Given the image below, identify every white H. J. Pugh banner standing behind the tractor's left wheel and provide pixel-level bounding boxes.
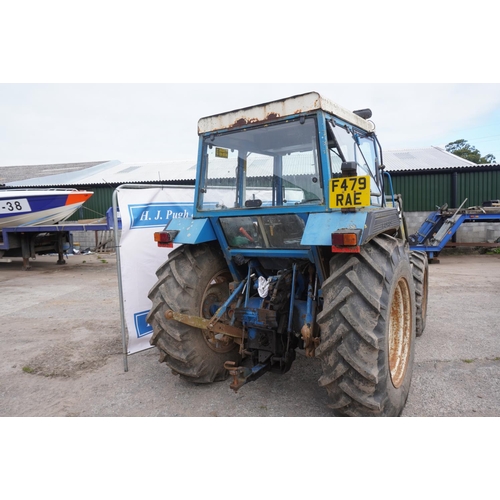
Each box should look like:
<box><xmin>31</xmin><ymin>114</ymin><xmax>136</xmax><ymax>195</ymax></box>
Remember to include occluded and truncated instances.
<box><xmin>118</xmin><ymin>186</ymin><xmax>194</xmax><ymax>354</ymax></box>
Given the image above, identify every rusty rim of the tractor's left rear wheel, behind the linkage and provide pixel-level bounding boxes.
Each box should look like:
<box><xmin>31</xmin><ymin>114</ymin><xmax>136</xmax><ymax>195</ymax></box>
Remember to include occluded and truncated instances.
<box><xmin>200</xmin><ymin>271</ymin><xmax>234</xmax><ymax>353</ymax></box>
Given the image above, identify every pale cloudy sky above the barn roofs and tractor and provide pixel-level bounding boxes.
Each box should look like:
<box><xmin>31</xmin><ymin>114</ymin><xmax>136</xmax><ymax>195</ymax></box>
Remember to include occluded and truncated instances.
<box><xmin>0</xmin><ymin>83</ymin><xmax>500</xmax><ymax>166</ymax></box>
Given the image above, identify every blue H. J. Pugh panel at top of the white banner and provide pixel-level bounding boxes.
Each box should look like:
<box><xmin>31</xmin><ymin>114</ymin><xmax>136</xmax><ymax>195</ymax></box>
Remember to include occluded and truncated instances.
<box><xmin>128</xmin><ymin>202</ymin><xmax>193</xmax><ymax>229</ymax></box>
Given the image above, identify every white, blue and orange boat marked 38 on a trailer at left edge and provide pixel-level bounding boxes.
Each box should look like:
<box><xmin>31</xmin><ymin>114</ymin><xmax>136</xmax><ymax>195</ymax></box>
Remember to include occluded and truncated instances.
<box><xmin>0</xmin><ymin>188</ymin><xmax>94</xmax><ymax>228</ymax></box>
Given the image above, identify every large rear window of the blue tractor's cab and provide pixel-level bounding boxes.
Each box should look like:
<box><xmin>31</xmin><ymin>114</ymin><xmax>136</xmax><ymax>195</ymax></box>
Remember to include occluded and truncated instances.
<box><xmin>198</xmin><ymin>117</ymin><xmax>323</xmax><ymax>210</ymax></box>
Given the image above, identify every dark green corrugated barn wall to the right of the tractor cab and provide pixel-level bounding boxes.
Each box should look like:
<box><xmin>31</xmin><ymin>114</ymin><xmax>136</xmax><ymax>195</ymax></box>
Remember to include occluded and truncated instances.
<box><xmin>392</xmin><ymin>170</ymin><xmax>500</xmax><ymax>212</ymax></box>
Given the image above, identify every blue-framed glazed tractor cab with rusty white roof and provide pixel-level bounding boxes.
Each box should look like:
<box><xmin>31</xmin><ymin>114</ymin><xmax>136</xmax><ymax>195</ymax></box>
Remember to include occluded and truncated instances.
<box><xmin>194</xmin><ymin>93</ymin><xmax>383</xmax><ymax>218</ymax></box>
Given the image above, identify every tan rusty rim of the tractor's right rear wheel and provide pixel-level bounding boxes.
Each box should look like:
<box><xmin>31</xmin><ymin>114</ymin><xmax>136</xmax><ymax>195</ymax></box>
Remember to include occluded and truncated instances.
<box><xmin>389</xmin><ymin>278</ymin><xmax>412</xmax><ymax>388</ymax></box>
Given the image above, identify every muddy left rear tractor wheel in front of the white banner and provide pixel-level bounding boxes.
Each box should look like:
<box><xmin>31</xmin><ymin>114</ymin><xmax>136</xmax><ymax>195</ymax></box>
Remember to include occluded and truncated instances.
<box><xmin>147</xmin><ymin>244</ymin><xmax>240</xmax><ymax>384</ymax></box>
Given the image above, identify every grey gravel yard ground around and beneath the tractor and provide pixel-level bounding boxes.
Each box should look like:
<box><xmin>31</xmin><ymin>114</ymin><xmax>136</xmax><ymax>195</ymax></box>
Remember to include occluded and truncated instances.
<box><xmin>0</xmin><ymin>250</ymin><xmax>500</xmax><ymax>417</ymax></box>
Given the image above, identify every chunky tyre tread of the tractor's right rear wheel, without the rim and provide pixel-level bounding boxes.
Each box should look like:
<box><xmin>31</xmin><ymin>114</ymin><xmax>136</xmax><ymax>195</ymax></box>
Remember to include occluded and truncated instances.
<box><xmin>316</xmin><ymin>235</ymin><xmax>413</xmax><ymax>416</ymax></box>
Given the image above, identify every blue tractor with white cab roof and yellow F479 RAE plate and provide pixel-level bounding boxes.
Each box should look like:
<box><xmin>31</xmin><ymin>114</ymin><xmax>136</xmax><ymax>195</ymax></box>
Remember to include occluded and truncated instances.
<box><xmin>147</xmin><ymin>92</ymin><xmax>428</xmax><ymax>416</ymax></box>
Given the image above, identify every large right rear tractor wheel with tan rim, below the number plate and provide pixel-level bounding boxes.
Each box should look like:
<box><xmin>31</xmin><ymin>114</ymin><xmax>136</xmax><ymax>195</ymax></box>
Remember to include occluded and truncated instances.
<box><xmin>316</xmin><ymin>235</ymin><xmax>415</xmax><ymax>416</ymax></box>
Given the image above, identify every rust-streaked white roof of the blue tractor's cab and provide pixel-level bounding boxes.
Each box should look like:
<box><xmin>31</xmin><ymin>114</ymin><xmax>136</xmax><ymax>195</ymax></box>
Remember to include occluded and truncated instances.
<box><xmin>198</xmin><ymin>92</ymin><xmax>375</xmax><ymax>135</ymax></box>
